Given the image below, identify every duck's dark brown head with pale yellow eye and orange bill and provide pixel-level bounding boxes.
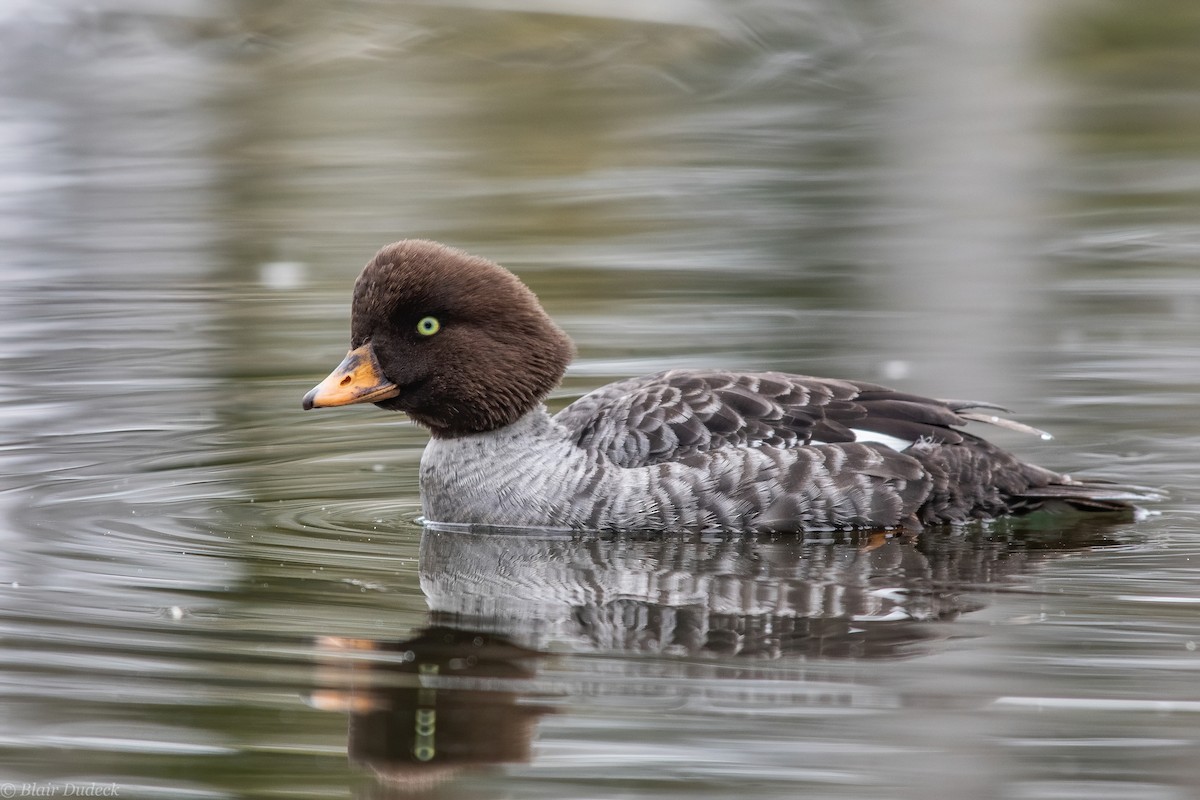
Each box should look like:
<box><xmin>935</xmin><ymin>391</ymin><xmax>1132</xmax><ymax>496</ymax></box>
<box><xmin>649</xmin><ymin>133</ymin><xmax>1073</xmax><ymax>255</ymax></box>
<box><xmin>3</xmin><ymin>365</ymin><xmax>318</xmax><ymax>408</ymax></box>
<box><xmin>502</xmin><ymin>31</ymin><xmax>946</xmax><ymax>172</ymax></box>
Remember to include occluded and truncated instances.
<box><xmin>304</xmin><ymin>240</ymin><xmax>574</xmax><ymax>437</ymax></box>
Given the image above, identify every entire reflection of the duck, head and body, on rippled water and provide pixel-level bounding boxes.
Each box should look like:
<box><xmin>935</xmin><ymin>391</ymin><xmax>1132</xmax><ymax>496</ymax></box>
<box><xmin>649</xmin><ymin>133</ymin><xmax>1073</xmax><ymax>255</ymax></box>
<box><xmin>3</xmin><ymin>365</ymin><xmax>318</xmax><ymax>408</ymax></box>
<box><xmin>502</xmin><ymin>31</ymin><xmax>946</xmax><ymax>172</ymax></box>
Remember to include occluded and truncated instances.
<box><xmin>313</xmin><ymin>521</ymin><xmax>1114</xmax><ymax>795</ymax></box>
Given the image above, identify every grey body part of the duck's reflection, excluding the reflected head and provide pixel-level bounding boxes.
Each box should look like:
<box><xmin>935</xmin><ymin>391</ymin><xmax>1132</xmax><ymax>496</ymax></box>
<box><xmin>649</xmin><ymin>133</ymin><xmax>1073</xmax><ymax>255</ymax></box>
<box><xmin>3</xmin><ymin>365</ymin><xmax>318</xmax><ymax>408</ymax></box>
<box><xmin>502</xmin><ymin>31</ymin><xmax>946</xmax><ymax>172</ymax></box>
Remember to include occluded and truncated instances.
<box><xmin>420</xmin><ymin>521</ymin><xmax>1112</xmax><ymax>658</ymax></box>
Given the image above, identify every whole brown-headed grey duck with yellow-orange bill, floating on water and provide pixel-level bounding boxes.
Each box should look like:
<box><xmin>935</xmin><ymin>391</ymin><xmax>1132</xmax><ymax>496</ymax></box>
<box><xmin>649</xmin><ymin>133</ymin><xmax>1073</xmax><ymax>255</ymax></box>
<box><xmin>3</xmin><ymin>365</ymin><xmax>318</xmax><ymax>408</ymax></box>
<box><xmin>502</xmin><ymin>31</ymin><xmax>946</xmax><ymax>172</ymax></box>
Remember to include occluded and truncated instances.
<box><xmin>302</xmin><ymin>239</ymin><xmax>1150</xmax><ymax>533</ymax></box>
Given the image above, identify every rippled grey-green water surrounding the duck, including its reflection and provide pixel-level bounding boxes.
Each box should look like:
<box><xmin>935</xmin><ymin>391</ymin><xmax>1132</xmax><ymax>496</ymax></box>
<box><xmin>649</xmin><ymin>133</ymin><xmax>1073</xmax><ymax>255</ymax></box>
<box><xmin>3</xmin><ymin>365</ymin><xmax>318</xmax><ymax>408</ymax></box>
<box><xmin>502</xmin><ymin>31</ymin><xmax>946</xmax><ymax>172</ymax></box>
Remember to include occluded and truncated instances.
<box><xmin>0</xmin><ymin>0</ymin><xmax>1200</xmax><ymax>800</ymax></box>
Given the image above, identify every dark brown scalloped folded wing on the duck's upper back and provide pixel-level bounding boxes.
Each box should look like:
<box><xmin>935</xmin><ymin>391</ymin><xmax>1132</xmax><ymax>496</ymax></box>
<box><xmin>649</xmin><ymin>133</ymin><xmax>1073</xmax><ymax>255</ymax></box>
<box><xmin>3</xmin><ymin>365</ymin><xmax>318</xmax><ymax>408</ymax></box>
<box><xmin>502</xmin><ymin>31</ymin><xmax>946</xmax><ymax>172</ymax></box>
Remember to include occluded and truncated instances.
<box><xmin>556</xmin><ymin>369</ymin><xmax>978</xmax><ymax>467</ymax></box>
